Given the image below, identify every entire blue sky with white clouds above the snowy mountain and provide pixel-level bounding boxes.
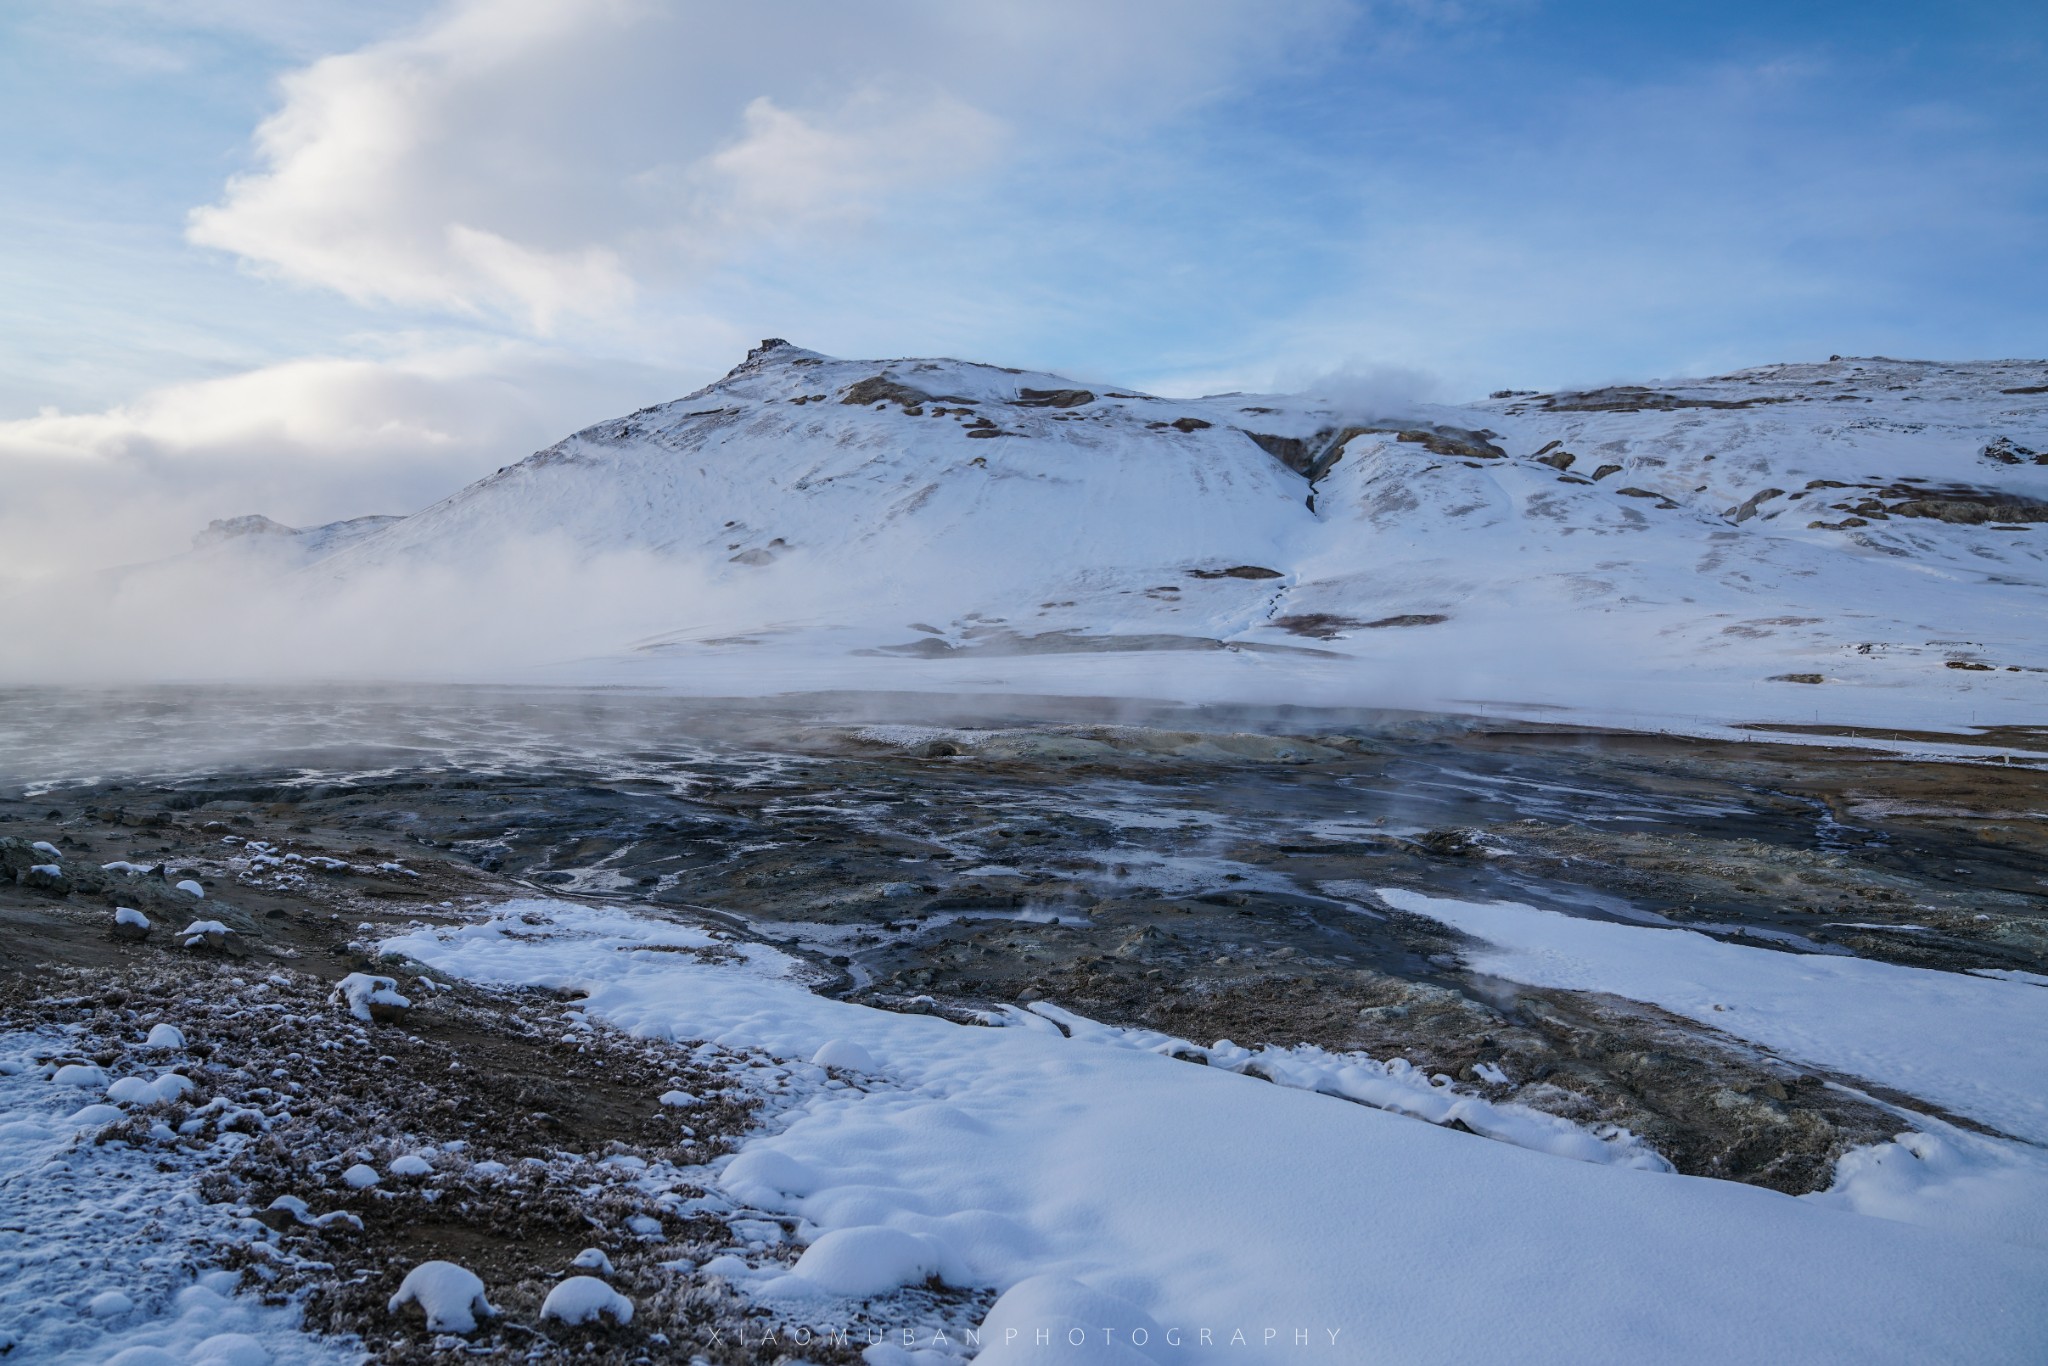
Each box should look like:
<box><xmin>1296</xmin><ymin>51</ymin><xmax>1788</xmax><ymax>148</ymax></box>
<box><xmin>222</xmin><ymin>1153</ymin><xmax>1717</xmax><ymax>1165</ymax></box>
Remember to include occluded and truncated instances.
<box><xmin>0</xmin><ymin>0</ymin><xmax>2048</xmax><ymax>571</ymax></box>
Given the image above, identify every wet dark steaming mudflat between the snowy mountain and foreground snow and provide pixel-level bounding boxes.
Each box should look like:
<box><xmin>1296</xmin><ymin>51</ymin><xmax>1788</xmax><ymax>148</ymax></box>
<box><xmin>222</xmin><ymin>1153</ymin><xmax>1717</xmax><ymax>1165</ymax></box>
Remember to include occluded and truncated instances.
<box><xmin>0</xmin><ymin>690</ymin><xmax>2048</xmax><ymax>1220</ymax></box>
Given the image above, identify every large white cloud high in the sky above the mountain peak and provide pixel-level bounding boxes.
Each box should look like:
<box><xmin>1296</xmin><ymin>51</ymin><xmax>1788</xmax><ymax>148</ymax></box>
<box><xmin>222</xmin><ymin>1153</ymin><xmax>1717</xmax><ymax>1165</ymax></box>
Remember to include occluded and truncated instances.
<box><xmin>188</xmin><ymin>0</ymin><xmax>1343</xmax><ymax>332</ymax></box>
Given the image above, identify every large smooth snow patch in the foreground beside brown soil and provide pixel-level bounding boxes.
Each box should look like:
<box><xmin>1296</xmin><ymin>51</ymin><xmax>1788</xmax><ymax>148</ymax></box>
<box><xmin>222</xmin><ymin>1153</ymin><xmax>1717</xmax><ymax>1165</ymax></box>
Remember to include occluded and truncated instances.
<box><xmin>385</xmin><ymin>901</ymin><xmax>2048</xmax><ymax>1362</ymax></box>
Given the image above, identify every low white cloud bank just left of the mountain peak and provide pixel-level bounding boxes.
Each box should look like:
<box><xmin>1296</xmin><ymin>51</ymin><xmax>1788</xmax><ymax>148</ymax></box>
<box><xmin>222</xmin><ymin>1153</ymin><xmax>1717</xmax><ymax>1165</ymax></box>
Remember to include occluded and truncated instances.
<box><xmin>0</xmin><ymin>346</ymin><xmax>692</xmax><ymax>586</ymax></box>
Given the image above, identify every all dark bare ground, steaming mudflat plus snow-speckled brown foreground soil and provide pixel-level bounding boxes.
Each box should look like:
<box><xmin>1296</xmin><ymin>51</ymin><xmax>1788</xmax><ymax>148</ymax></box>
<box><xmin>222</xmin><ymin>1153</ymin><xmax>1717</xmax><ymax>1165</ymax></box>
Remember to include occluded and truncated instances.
<box><xmin>0</xmin><ymin>692</ymin><xmax>2048</xmax><ymax>1364</ymax></box>
